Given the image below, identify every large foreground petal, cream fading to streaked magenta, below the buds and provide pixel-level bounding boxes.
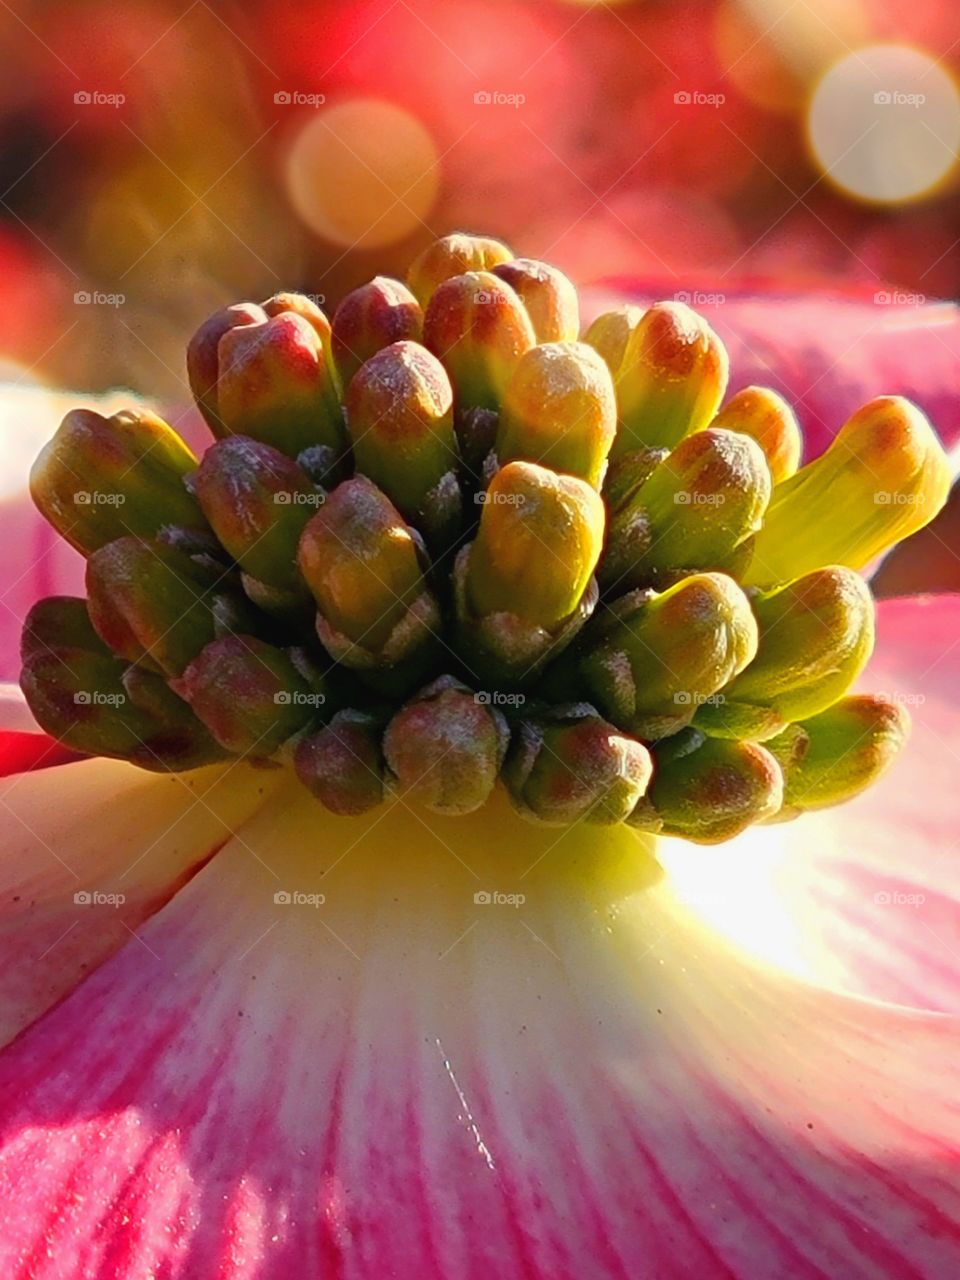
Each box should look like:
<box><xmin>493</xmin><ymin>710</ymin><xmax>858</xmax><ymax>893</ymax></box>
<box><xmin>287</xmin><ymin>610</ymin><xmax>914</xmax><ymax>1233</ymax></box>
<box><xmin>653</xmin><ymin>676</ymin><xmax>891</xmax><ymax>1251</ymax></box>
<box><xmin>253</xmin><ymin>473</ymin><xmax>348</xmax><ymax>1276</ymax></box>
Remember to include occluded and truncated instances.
<box><xmin>0</xmin><ymin>773</ymin><xmax>960</xmax><ymax>1280</ymax></box>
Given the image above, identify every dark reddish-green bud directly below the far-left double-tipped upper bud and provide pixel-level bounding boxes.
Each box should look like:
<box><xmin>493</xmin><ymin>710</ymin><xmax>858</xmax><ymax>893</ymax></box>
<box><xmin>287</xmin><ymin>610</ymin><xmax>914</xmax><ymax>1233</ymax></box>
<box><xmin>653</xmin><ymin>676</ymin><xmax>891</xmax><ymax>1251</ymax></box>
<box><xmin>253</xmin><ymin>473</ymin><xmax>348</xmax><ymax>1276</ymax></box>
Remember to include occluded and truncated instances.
<box><xmin>87</xmin><ymin>538</ymin><xmax>224</xmax><ymax>676</ymax></box>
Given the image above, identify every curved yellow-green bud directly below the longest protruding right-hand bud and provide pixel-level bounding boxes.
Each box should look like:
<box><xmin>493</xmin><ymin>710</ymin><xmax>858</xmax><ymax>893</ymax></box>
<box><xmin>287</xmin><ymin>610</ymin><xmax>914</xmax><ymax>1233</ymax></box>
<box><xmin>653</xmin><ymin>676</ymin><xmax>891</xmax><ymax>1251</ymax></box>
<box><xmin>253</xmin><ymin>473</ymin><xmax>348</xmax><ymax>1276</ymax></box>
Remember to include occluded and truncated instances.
<box><xmin>696</xmin><ymin>564</ymin><xmax>874</xmax><ymax>739</ymax></box>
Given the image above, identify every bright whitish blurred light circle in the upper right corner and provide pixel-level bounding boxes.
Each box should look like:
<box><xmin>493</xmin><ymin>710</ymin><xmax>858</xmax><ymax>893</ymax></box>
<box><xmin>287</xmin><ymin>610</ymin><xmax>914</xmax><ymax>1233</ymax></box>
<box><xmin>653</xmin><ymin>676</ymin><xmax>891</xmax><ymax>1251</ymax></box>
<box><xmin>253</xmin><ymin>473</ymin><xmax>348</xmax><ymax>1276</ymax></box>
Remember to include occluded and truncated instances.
<box><xmin>808</xmin><ymin>45</ymin><xmax>960</xmax><ymax>204</ymax></box>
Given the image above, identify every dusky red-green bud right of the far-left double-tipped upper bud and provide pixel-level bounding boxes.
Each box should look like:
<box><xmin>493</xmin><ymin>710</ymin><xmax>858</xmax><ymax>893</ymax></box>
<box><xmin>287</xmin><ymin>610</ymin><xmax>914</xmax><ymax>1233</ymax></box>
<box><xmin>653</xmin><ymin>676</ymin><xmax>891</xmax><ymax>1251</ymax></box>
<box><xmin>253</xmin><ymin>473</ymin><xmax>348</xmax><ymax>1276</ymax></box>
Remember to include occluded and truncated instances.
<box><xmin>195</xmin><ymin>435</ymin><xmax>324</xmax><ymax>588</ymax></box>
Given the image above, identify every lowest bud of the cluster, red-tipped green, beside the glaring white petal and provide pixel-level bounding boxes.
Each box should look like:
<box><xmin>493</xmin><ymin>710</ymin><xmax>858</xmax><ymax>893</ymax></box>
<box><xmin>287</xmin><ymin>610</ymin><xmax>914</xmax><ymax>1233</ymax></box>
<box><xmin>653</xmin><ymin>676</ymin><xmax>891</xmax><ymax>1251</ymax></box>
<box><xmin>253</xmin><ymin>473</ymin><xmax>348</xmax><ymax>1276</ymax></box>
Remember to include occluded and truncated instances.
<box><xmin>628</xmin><ymin>733</ymin><xmax>783</xmax><ymax>845</ymax></box>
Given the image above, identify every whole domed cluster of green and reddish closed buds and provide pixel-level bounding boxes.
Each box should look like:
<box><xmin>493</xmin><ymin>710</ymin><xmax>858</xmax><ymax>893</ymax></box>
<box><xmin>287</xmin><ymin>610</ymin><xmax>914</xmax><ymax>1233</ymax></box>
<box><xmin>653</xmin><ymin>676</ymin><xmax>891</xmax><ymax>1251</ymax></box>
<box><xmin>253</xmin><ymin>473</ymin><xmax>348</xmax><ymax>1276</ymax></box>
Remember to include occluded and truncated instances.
<box><xmin>22</xmin><ymin>236</ymin><xmax>948</xmax><ymax>842</ymax></box>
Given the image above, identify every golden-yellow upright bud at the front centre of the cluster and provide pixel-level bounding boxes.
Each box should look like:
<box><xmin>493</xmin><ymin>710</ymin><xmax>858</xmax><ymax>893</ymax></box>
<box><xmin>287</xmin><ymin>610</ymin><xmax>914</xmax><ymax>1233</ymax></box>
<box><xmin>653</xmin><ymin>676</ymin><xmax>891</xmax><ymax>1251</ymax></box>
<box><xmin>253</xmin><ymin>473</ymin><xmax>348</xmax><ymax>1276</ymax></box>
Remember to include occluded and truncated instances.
<box><xmin>466</xmin><ymin>462</ymin><xmax>604</xmax><ymax>630</ymax></box>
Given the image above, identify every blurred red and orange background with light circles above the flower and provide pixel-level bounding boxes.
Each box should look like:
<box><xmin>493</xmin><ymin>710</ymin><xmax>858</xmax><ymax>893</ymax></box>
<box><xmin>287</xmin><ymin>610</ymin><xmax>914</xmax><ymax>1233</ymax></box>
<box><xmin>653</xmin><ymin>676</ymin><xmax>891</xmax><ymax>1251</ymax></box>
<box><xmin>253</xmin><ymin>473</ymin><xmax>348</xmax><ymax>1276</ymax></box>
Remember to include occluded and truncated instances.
<box><xmin>0</xmin><ymin>0</ymin><xmax>960</xmax><ymax>399</ymax></box>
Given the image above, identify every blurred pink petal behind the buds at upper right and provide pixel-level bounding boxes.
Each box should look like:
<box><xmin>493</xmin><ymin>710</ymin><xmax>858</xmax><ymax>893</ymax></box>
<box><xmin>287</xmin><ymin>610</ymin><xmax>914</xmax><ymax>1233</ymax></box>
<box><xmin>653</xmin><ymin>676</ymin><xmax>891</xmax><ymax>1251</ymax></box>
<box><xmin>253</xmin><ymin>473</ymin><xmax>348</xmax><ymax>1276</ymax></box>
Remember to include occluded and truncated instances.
<box><xmin>584</xmin><ymin>280</ymin><xmax>960</xmax><ymax>461</ymax></box>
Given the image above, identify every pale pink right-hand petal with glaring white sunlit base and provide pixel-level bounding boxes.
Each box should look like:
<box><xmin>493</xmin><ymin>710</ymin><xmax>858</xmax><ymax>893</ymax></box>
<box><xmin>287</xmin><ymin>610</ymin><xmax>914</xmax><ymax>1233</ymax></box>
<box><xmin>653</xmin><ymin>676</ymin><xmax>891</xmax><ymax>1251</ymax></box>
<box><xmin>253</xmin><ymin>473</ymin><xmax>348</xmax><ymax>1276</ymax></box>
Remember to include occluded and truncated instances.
<box><xmin>662</xmin><ymin>595</ymin><xmax>960</xmax><ymax>1012</ymax></box>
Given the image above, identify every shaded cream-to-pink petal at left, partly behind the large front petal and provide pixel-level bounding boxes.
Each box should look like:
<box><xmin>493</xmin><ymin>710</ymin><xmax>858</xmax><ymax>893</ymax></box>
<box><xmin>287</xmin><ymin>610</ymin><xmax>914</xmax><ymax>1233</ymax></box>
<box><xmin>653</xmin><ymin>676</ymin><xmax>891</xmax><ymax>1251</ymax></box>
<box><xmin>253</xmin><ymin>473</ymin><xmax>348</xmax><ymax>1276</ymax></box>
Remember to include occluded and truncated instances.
<box><xmin>0</xmin><ymin>736</ymin><xmax>276</xmax><ymax>1043</ymax></box>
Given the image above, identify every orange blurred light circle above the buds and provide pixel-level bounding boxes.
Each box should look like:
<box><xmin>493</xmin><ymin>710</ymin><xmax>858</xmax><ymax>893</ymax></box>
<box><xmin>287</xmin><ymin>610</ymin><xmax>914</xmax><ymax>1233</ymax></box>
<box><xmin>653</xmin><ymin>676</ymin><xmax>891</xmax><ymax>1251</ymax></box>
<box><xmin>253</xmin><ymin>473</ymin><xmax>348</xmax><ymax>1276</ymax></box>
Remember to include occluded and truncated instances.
<box><xmin>287</xmin><ymin>99</ymin><xmax>440</xmax><ymax>250</ymax></box>
